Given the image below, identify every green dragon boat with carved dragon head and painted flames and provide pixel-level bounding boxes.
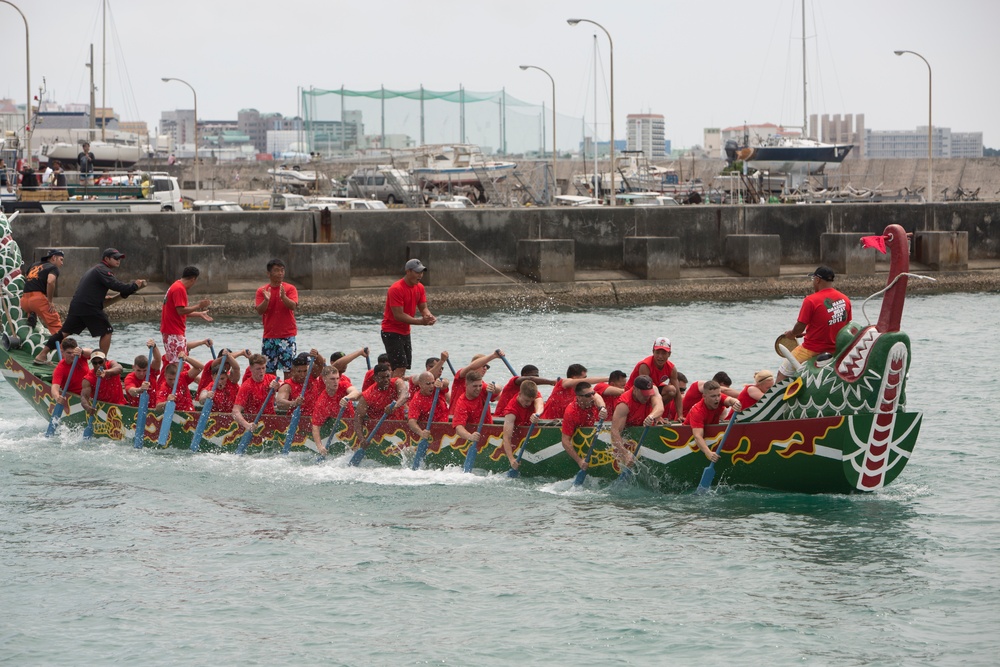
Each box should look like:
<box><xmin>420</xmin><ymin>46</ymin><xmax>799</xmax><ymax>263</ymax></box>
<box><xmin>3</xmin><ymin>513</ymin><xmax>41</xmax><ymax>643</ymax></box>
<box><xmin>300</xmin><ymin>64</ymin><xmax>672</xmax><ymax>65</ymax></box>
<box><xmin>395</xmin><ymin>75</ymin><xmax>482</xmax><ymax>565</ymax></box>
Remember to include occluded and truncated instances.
<box><xmin>0</xmin><ymin>214</ymin><xmax>921</xmax><ymax>493</ymax></box>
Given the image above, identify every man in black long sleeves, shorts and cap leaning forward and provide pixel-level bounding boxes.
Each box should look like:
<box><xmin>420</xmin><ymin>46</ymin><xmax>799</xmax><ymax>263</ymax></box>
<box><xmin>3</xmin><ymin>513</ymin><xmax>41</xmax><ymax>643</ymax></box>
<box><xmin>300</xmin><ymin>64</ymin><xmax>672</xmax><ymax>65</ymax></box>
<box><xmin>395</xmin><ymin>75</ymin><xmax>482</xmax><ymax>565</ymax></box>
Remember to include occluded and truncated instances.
<box><xmin>35</xmin><ymin>248</ymin><xmax>146</xmax><ymax>364</ymax></box>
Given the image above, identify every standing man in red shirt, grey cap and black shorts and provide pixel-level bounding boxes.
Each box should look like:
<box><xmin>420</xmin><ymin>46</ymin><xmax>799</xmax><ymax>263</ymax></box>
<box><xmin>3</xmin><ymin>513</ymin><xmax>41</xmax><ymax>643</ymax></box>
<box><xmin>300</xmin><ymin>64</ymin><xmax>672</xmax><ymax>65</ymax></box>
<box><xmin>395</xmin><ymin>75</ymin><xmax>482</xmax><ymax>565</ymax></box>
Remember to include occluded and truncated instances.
<box><xmin>382</xmin><ymin>259</ymin><xmax>437</xmax><ymax>378</ymax></box>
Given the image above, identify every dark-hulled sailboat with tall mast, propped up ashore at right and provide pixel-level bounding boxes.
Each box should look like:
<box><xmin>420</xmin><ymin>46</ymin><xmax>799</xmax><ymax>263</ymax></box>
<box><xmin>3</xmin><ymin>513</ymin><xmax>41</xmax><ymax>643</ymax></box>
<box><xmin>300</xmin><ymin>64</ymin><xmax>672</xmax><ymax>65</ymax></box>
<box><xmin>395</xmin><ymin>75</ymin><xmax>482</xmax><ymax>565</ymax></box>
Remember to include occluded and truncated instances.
<box><xmin>725</xmin><ymin>0</ymin><xmax>854</xmax><ymax>174</ymax></box>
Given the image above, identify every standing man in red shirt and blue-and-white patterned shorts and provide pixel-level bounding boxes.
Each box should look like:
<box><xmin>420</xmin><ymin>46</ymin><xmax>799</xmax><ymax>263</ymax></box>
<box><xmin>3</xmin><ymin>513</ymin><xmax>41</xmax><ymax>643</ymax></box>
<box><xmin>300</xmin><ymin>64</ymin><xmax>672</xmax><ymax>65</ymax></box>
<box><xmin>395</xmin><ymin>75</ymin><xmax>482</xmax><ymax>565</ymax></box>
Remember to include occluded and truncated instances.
<box><xmin>254</xmin><ymin>259</ymin><xmax>299</xmax><ymax>374</ymax></box>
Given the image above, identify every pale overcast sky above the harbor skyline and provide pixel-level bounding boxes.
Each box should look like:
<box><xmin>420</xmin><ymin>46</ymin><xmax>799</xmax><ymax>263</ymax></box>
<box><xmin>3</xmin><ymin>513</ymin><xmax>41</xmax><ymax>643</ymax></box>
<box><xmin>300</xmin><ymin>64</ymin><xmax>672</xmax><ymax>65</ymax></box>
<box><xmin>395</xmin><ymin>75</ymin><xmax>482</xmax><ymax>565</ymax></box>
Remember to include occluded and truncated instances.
<box><xmin>7</xmin><ymin>0</ymin><xmax>1000</xmax><ymax>148</ymax></box>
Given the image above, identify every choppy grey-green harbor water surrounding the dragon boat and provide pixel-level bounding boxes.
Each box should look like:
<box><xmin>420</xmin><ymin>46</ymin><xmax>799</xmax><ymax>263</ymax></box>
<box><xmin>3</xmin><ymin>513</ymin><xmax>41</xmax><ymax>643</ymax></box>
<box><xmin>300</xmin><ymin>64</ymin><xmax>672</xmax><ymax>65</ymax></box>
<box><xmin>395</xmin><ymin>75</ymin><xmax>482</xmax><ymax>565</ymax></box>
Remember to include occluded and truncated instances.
<box><xmin>0</xmin><ymin>290</ymin><xmax>1000</xmax><ymax>665</ymax></box>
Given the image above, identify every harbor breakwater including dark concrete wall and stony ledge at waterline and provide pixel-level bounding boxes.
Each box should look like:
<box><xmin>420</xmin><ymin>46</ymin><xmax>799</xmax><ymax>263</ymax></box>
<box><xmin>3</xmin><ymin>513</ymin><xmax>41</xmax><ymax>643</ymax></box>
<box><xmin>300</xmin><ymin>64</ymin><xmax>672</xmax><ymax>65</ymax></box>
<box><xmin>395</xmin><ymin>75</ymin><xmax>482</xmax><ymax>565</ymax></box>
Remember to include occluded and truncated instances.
<box><xmin>14</xmin><ymin>202</ymin><xmax>1000</xmax><ymax>316</ymax></box>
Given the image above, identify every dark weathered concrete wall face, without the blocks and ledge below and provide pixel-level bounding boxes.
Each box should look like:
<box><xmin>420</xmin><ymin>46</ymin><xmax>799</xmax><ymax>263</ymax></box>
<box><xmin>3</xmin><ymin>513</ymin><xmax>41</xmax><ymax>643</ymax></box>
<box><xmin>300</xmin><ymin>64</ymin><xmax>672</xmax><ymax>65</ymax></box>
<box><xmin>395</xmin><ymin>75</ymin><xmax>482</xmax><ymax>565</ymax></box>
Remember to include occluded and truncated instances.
<box><xmin>14</xmin><ymin>202</ymin><xmax>1000</xmax><ymax>281</ymax></box>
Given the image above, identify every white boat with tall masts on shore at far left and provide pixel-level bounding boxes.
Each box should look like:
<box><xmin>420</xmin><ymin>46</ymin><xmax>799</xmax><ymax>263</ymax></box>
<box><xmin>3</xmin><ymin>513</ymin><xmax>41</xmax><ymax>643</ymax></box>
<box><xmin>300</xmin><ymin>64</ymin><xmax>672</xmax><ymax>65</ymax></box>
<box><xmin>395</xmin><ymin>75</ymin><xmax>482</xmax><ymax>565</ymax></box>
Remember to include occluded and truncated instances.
<box><xmin>35</xmin><ymin>0</ymin><xmax>150</xmax><ymax>169</ymax></box>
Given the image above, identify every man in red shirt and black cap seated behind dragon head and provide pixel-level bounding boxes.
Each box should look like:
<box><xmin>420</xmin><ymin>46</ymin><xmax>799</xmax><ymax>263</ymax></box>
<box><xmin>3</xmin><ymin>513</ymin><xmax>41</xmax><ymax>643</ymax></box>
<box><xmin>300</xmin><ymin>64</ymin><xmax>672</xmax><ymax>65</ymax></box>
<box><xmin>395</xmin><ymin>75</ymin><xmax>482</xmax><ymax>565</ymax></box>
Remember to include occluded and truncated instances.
<box><xmin>777</xmin><ymin>266</ymin><xmax>851</xmax><ymax>382</ymax></box>
